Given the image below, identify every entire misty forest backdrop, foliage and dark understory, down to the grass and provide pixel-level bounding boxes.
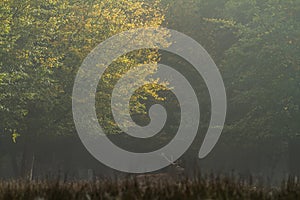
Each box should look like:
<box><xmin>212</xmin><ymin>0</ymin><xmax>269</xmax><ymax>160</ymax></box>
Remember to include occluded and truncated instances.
<box><xmin>0</xmin><ymin>0</ymin><xmax>300</xmax><ymax>191</ymax></box>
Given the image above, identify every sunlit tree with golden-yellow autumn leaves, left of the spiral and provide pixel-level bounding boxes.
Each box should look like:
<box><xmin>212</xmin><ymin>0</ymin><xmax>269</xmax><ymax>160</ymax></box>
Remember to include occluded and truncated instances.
<box><xmin>0</xmin><ymin>0</ymin><xmax>163</xmax><ymax>177</ymax></box>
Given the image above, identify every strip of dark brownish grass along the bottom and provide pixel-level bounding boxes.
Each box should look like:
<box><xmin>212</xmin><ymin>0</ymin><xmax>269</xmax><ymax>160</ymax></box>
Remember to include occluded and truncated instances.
<box><xmin>0</xmin><ymin>177</ymin><xmax>300</xmax><ymax>200</ymax></box>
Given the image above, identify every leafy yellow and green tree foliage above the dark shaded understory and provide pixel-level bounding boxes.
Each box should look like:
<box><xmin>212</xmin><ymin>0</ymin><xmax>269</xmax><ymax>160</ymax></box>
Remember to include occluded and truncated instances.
<box><xmin>0</xmin><ymin>0</ymin><xmax>300</xmax><ymax>178</ymax></box>
